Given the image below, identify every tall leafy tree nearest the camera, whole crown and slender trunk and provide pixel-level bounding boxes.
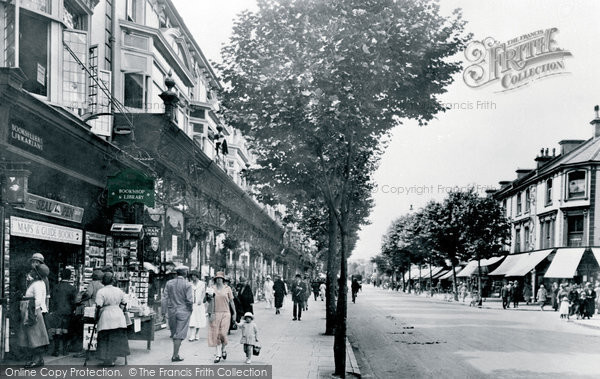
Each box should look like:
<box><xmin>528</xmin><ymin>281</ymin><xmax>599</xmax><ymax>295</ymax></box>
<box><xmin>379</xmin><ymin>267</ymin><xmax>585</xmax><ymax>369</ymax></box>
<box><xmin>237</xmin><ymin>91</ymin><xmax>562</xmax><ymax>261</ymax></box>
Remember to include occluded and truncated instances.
<box><xmin>218</xmin><ymin>0</ymin><xmax>469</xmax><ymax>376</ymax></box>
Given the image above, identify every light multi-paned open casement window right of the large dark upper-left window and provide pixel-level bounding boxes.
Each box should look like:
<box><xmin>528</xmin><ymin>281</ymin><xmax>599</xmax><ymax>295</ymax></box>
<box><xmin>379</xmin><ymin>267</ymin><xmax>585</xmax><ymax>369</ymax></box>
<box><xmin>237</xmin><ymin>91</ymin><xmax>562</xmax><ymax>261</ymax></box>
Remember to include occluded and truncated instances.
<box><xmin>62</xmin><ymin>30</ymin><xmax>88</xmax><ymax>115</ymax></box>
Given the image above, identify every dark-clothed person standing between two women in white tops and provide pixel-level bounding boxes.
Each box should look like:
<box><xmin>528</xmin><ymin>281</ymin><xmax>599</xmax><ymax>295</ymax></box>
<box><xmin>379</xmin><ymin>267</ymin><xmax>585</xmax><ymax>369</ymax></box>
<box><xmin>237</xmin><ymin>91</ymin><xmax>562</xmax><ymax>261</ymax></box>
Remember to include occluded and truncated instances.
<box><xmin>48</xmin><ymin>268</ymin><xmax>77</xmax><ymax>357</ymax></box>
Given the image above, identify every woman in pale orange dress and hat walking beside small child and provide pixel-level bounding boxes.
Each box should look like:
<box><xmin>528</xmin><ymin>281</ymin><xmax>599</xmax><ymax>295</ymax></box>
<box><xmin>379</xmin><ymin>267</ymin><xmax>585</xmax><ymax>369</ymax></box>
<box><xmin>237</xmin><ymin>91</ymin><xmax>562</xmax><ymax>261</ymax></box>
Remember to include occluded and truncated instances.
<box><xmin>206</xmin><ymin>271</ymin><xmax>236</xmax><ymax>363</ymax></box>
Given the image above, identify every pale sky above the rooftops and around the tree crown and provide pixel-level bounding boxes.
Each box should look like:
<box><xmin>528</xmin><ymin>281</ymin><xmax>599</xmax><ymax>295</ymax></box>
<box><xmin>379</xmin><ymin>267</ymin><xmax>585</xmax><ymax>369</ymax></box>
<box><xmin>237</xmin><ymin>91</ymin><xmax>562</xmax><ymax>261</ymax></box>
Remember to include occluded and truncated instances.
<box><xmin>173</xmin><ymin>0</ymin><xmax>600</xmax><ymax>259</ymax></box>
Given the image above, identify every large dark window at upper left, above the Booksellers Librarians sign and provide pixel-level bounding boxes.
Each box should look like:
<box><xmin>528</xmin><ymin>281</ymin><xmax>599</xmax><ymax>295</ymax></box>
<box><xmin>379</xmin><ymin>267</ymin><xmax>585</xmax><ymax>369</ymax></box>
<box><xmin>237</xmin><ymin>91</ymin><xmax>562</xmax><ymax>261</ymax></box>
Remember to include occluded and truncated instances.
<box><xmin>19</xmin><ymin>12</ymin><xmax>49</xmax><ymax>96</ymax></box>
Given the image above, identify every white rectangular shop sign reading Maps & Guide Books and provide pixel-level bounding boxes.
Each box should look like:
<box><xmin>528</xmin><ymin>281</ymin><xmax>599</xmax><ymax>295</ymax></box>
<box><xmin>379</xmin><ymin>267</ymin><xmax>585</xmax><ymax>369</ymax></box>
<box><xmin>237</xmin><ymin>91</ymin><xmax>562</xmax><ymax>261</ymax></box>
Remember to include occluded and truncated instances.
<box><xmin>10</xmin><ymin>216</ymin><xmax>83</xmax><ymax>245</ymax></box>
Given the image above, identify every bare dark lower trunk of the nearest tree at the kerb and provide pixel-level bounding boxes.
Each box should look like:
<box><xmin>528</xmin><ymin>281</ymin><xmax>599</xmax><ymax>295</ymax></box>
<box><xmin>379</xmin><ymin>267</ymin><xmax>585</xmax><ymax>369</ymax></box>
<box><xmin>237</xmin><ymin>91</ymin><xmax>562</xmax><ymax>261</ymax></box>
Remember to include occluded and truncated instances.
<box><xmin>333</xmin><ymin>212</ymin><xmax>348</xmax><ymax>378</ymax></box>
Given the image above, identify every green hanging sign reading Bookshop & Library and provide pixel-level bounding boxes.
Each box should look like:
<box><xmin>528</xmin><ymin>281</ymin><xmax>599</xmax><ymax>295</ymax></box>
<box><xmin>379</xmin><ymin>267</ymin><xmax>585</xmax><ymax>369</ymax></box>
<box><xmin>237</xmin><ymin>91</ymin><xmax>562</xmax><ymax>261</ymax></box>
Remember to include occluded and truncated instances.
<box><xmin>108</xmin><ymin>170</ymin><xmax>154</xmax><ymax>208</ymax></box>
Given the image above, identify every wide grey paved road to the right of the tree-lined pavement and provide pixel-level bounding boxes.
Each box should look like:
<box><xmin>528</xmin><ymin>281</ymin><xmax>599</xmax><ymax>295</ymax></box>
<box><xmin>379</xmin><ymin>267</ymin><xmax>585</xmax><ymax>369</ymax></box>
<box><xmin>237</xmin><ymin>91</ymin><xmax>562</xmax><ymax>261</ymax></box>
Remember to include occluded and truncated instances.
<box><xmin>348</xmin><ymin>285</ymin><xmax>600</xmax><ymax>378</ymax></box>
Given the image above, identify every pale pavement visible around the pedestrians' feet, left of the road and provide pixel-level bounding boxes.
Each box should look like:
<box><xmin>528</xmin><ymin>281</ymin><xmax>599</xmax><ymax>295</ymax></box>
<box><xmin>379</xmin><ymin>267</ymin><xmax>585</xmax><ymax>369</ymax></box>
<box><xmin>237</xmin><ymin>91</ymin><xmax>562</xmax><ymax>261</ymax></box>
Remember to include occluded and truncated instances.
<box><xmin>4</xmin><ymin>296</ymin><xmax>360</xmax><ymax>379</ymax></box>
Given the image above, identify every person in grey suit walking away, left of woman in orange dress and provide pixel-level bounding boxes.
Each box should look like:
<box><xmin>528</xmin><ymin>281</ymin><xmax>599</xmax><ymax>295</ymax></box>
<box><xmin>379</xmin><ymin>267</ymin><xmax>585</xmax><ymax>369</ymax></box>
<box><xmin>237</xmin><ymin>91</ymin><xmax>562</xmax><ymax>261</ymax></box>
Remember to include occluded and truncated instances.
<box><xmin>162</xmin><ymin>266</ymin><xmax>194</xmax><ymax>362</ymax></box>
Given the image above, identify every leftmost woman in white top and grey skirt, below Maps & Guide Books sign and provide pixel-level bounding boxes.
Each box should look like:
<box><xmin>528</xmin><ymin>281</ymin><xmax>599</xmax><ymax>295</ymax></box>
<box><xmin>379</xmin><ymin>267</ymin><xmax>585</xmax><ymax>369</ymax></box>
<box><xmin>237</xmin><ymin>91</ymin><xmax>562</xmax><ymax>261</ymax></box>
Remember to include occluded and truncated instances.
<box><xmin>18</xmin><ymin>263</ymin><xmax>50</xmax><ymax>368</ymax></box>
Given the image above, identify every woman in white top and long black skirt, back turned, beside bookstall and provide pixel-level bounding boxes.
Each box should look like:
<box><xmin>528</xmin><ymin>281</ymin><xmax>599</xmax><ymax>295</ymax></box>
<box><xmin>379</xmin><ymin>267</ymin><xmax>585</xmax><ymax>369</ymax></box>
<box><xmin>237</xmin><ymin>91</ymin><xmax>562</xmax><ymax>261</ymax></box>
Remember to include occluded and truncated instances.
<box><xmin>96</xmin><ymin>271</ymin><xmax>129</xmax><ymax>367</ymax></box>
